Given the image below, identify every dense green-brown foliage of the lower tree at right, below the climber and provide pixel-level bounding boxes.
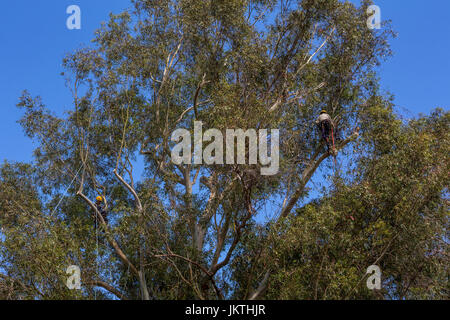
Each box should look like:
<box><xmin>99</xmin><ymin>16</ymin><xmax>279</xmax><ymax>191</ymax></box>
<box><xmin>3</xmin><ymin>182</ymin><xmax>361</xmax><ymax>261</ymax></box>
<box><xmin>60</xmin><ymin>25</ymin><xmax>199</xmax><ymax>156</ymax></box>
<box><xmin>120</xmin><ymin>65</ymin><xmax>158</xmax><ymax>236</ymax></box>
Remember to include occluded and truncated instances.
<box><xmin>262</xmin><ymin>110</ymin><xmax>450</xmax><ymax>299</ymax></box>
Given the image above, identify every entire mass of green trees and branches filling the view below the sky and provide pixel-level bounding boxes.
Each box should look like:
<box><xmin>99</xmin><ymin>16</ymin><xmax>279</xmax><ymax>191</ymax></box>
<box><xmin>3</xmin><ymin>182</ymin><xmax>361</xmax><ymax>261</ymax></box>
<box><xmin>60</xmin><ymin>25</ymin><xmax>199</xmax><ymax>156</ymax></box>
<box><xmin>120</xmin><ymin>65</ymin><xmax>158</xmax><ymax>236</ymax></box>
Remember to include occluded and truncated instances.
<box><xmin>0</xmin><ymin>0</ymin><xmax>450</xmax><ymax>299</ymax></box>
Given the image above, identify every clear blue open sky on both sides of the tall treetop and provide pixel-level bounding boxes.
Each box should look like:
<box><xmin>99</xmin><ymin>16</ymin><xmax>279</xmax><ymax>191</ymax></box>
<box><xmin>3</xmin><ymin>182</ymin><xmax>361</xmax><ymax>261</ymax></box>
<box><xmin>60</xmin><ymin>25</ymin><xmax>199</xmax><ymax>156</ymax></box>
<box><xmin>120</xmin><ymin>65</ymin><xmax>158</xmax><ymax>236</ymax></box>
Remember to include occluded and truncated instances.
<box><xmin>0</xmin><ymin>0</ymin><xmax>450</xmax><ymax>162</ymax></box>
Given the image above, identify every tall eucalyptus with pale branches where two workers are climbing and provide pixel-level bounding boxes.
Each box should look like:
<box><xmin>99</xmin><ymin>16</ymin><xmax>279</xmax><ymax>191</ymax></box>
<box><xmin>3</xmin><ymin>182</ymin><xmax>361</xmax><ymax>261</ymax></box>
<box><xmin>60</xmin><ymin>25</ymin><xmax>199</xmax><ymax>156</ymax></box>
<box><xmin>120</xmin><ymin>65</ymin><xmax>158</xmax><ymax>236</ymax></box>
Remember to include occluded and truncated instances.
<box><xmin>0</xmin><ymin>0</ymin><xmax>410</xmax><ymax>299</ymax></box>
